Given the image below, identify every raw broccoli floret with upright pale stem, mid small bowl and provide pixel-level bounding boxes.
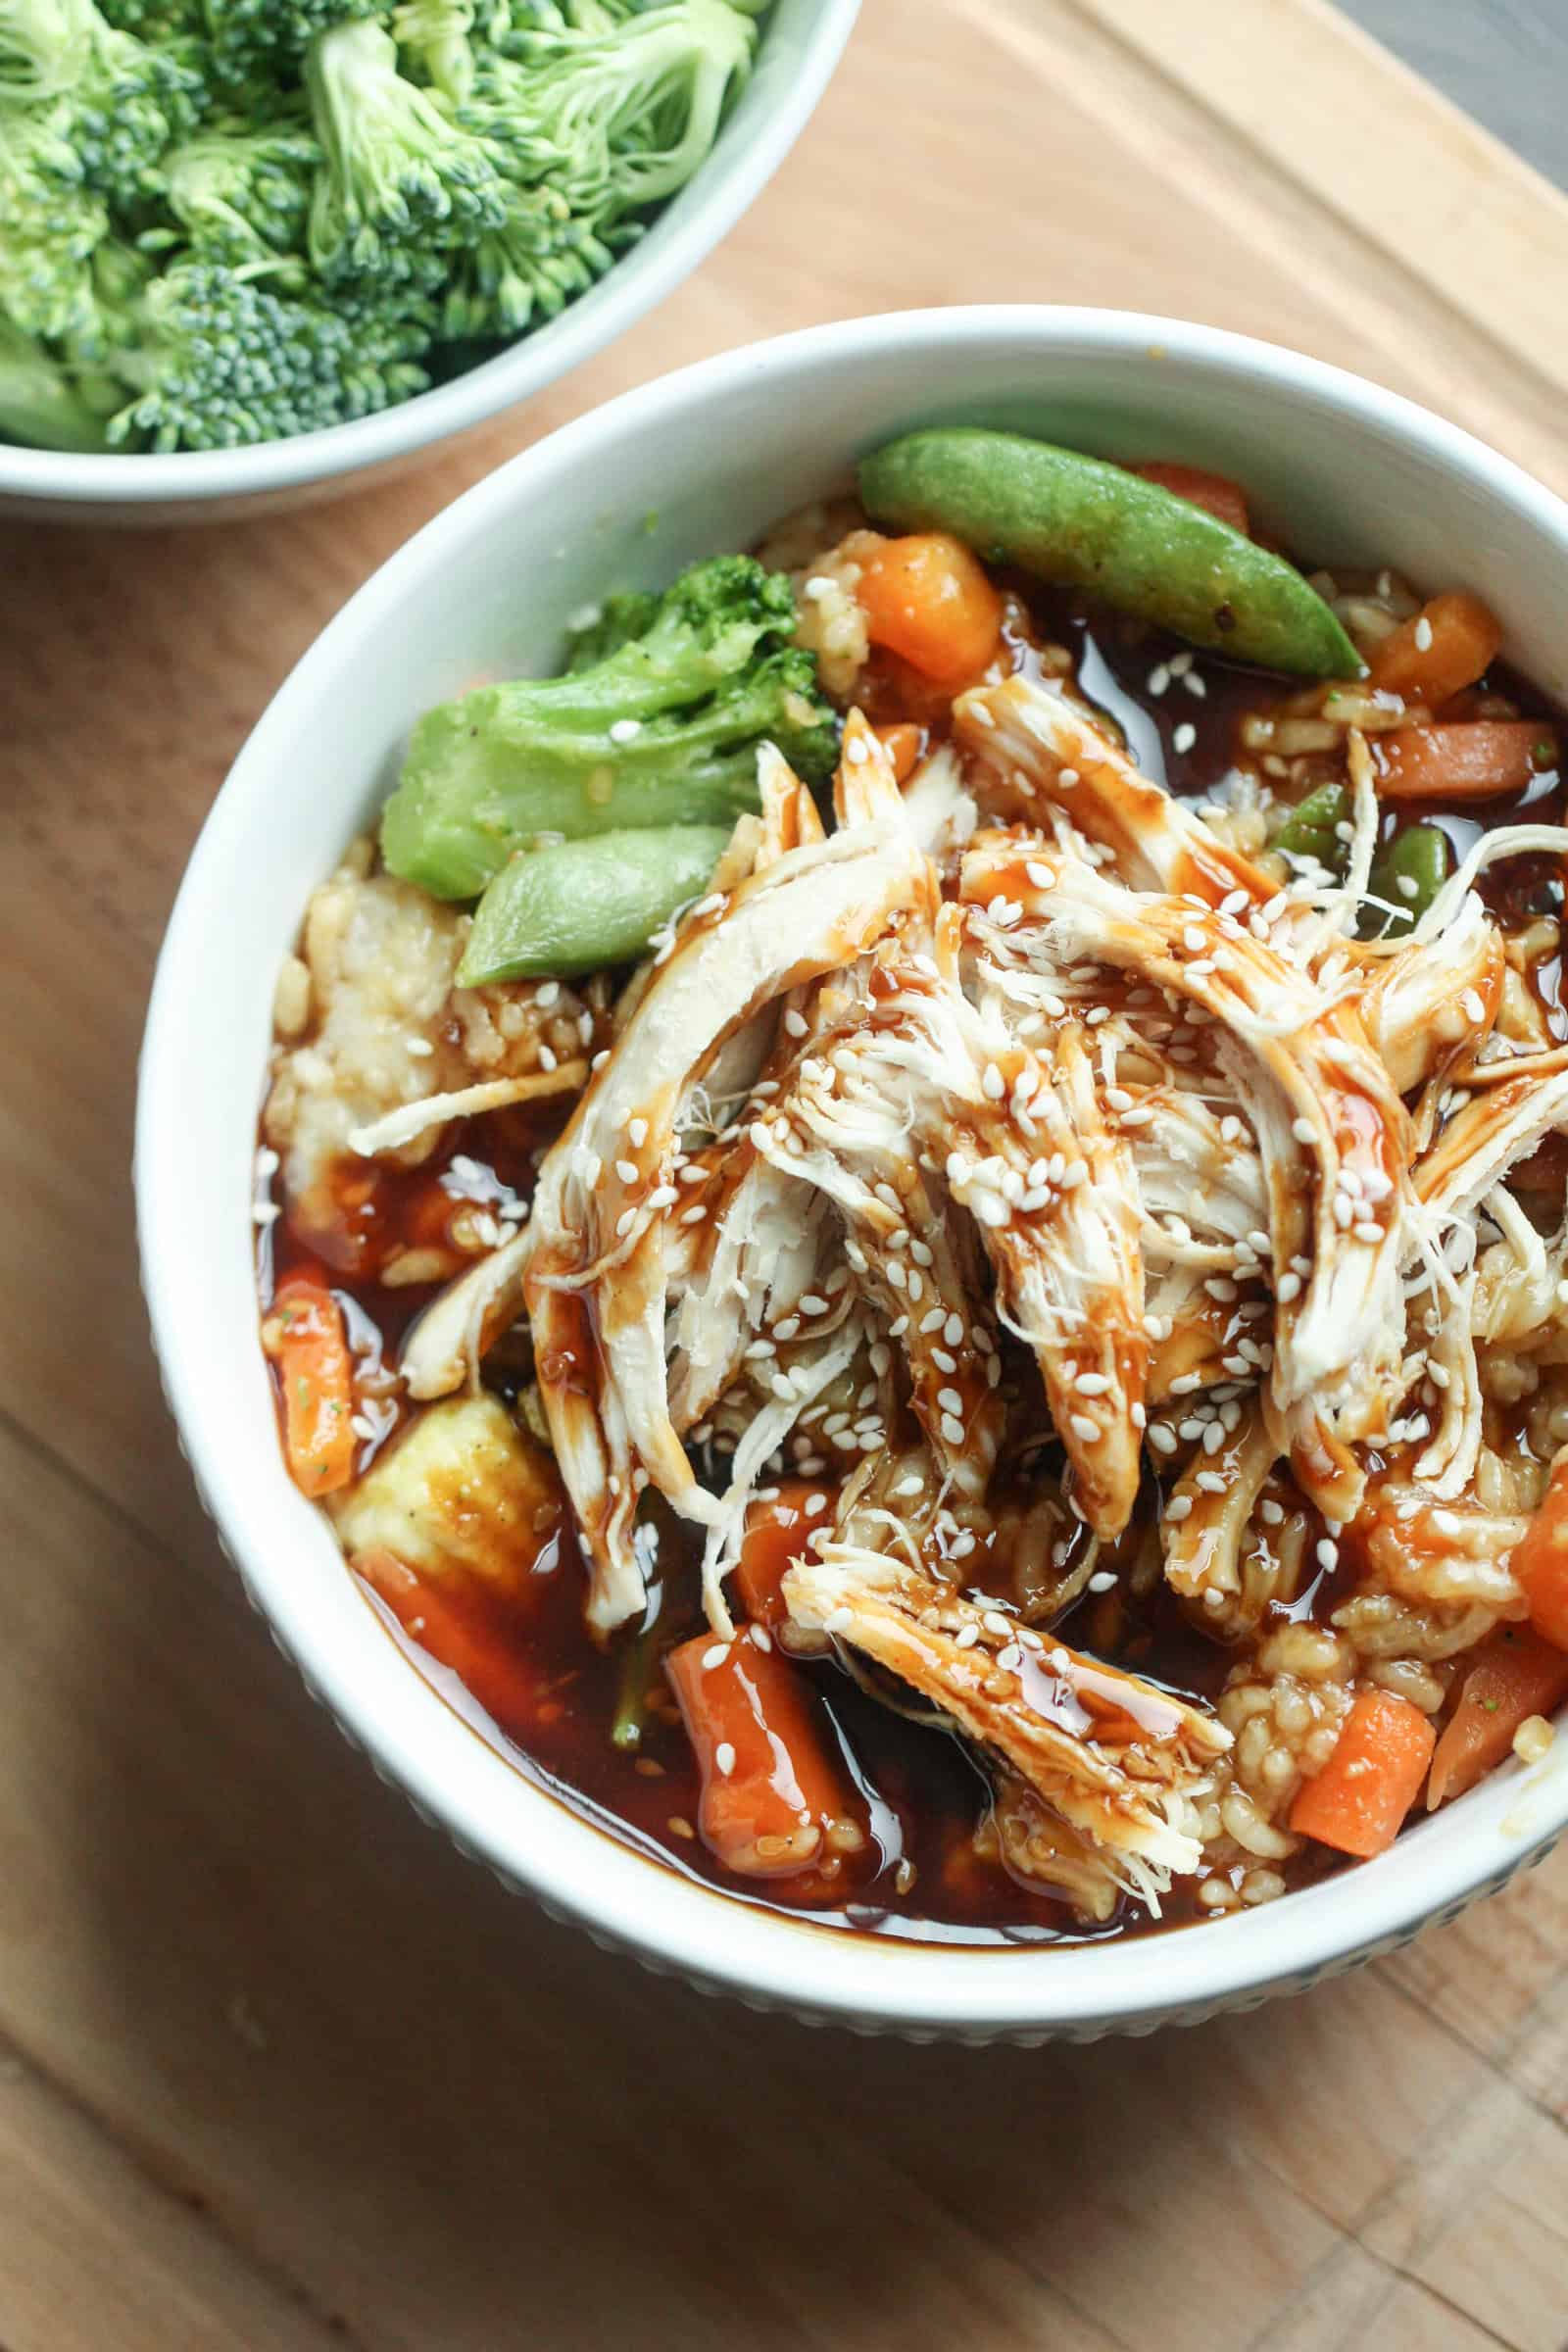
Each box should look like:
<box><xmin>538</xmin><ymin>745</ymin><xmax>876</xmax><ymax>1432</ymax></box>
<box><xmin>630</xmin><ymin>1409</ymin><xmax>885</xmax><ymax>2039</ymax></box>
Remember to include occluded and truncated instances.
<box><xmin>306</xmin><ymin>24</ymin><xmax>506</xmax><ymax>287</ymax></box>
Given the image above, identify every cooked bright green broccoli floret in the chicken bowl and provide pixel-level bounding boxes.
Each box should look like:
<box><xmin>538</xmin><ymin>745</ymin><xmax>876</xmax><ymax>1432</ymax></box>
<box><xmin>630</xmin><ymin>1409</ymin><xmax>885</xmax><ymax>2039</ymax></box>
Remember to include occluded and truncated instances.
<box><xmin>381</xmin><ymin>555</ymin><xmax>837</xmax><ymax>899</ymax></box>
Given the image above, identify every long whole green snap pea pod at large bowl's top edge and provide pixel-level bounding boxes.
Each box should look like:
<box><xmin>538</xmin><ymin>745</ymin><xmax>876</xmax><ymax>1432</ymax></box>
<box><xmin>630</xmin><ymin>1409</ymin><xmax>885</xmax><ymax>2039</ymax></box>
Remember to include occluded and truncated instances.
<box><xmin>860</xmin><ymin>425</ymin><xmax>1361</xmax><ymax>677</ymax></box>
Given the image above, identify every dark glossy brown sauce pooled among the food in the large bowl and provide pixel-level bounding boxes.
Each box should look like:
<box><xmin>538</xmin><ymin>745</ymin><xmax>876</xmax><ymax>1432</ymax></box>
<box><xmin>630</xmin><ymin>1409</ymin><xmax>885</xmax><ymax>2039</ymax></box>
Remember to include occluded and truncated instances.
<box><xmin>261</xmin><ymin>581</ymin><xmax>1568</xmax><ymax>1945</ymax></box>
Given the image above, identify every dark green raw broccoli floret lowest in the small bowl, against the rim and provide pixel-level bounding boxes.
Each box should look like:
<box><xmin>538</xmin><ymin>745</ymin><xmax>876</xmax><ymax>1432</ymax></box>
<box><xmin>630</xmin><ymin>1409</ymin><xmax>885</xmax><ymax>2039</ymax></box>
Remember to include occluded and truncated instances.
<box><xmin>108</xmin><ymin>261</ymin><xmax>430</xmax><ymax>449</ymax></box>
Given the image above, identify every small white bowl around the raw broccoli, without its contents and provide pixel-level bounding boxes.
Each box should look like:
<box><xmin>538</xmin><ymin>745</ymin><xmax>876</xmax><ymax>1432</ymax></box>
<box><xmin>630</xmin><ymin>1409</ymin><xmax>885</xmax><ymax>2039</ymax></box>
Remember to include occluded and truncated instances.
<box><xmin>0</xmin><ymin>0</ymin><xmax>860</xmax><ymax>524</ymax></box>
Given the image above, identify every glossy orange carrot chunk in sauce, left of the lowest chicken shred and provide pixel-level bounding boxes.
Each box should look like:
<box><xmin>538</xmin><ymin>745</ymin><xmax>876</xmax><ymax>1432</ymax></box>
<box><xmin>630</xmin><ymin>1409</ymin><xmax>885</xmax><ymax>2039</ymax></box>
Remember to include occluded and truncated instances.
<box><xmin>665</xmin><ymin>1633</ymin><xmax>860</xmax><ymax>1880</ymax></box>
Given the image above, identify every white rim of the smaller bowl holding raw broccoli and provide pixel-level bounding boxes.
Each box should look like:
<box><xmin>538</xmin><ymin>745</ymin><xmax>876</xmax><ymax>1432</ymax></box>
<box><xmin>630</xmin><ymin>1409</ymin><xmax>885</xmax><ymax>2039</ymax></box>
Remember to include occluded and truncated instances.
<box><xmin>0</xmin><ymin>0</ymin><xmax>860</xmax><ymax>511</ymax></box>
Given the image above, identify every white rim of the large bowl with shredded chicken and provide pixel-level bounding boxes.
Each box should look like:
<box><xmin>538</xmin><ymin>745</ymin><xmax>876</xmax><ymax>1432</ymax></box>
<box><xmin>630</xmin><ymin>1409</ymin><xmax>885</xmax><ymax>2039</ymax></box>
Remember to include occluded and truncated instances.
<box><xmin>136</xmin><ymin>304</ymin><xmax>1568</xmax><ymax>2039</ymax></box>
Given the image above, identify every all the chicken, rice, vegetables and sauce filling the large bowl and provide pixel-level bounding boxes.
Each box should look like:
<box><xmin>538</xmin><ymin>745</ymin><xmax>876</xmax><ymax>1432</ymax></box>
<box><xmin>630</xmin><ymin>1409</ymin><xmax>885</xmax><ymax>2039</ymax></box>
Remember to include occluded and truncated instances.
<box><xmin>259</xmin><ymin>428</ymin><xmax>1568</xmax><ymax>1940</ymax></box>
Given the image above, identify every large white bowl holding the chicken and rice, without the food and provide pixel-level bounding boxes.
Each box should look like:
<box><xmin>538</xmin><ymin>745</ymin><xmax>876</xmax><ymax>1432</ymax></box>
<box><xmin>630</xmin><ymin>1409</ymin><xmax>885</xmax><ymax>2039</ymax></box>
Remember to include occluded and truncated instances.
<box><xmin>136</xmin><ymin>308</ymin><xmax>1568</xmax><ymax>2041</ymax></box>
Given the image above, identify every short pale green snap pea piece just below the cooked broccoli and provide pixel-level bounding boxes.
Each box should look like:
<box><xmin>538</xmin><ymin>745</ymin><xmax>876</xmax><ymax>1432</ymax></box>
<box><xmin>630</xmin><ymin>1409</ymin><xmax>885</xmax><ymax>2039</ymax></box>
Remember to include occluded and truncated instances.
<box><xmin>459</xmin><ymin>825</ymin><xmax>729</xmax><ymax>988</ymax></box>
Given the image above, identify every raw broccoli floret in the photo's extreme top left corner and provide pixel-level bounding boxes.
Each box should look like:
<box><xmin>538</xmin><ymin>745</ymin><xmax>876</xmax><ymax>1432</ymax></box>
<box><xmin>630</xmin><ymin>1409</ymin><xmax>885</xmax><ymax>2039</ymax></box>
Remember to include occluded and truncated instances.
<box><xmin>0</xmin><ymin>0</ymin><xmax>205</xmax><ymax>205</ymax></box>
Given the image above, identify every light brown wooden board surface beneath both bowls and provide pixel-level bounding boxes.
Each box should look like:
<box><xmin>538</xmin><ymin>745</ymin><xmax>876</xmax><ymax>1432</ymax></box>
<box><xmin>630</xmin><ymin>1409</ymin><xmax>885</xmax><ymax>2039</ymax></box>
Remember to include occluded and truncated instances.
<box><xmin>0</xmin><ymin>0</ymin><xmax>1568</xmax><ymax>2352</ymax></box>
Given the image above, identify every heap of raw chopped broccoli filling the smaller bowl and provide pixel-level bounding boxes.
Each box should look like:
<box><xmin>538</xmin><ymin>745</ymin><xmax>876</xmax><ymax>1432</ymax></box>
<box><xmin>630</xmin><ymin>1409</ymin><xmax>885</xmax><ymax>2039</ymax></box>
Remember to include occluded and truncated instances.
<box><xmin>0</xmin><ymin>0</ymin><xmax>757</xmax><ymax>452</ymax></box>
